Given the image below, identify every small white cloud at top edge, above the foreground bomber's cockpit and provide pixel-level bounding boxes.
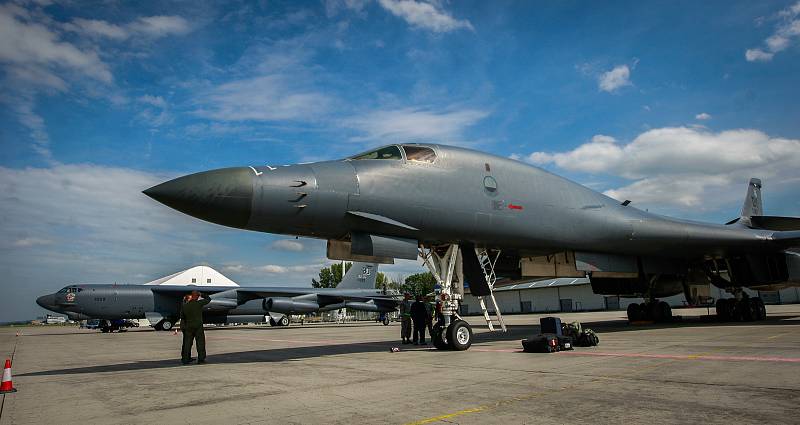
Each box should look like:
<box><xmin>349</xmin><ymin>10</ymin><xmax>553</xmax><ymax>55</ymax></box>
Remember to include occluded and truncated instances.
<box><xmin>378</xmin><ymin>0</ymin><xmax>473</xmax><ymax>33</ymax></box>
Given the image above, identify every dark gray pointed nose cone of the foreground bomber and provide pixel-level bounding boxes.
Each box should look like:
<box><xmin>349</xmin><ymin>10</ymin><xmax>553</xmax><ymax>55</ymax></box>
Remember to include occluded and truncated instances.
<box><xmin>143</xmin><ymin>167</ymin><xmax>253</xmax><ymax>228</ymax></box>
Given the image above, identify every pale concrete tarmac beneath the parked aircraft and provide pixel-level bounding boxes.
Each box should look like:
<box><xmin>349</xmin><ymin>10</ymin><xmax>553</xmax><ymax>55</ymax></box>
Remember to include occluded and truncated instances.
<box><xmin>0</xmin><ymin>305</ymin><xmax>800</xmax><ymax>425</ymax></box>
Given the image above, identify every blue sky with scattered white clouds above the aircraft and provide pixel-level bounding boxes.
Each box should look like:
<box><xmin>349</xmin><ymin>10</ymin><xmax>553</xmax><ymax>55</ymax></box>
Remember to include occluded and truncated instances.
<box><xmin>0</xmin><ymin>0</ymin><xmax>800</xmax><ymax>321</ymax></box>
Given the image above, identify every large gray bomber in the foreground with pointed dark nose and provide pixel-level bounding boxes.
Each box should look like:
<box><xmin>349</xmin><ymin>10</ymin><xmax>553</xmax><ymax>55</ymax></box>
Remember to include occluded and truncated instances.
<box><xmin>144</xmin><ymin>144</ymin><xmax>800</xmax><ymax>350</ymax></box>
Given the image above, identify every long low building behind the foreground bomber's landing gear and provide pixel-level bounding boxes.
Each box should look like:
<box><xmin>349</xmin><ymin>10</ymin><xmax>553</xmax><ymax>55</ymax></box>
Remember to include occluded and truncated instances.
<box><xmin>461</xmin><ymin>278</ymin><xmax>800</xmax><ymax>314</ymax></box>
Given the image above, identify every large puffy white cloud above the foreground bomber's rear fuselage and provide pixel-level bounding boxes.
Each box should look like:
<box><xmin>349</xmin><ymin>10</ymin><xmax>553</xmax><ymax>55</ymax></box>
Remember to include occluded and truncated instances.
<box><xmin>528</xmin><ymin>127</ymin><xmax>800</xmax><ymax>208</ymax></box>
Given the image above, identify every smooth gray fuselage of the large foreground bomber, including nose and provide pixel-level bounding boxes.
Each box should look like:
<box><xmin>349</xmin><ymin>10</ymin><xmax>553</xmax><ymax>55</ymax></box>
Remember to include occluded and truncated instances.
<box><xmin>145</xmin><ymin>145</ymin><xmax>770</xmax><ymax>258</ymax></box>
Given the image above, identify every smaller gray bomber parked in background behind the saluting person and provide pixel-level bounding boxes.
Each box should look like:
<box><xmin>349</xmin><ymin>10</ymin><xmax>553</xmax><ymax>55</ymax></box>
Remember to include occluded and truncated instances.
<box><xmin>36</xmin><ymin>263</ymin><xmax>398</xmax><ymax>330</ymax></box>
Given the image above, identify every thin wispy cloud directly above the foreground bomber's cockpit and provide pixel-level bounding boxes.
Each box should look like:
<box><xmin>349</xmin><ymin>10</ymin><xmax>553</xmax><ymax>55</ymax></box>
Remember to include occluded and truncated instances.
<box><xmin>343</xmin><ymin>108</ymin><xmax>489</xmax><ymax>142</ymax></box>
